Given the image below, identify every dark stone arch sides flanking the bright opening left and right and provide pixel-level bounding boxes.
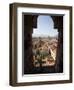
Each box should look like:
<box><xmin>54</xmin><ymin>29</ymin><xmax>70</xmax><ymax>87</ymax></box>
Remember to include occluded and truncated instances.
<box><xmin>24</xmin><ymin>15</ymin><xmax>63</xmax><ymax>74</ymax></box>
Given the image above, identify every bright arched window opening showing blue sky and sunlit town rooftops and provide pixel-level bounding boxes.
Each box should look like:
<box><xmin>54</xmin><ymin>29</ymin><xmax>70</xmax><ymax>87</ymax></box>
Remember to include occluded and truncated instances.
<box><xmin>32</xmin><ymin>15</ymin><xmax>58</xmax><ymax>72</ymax></box>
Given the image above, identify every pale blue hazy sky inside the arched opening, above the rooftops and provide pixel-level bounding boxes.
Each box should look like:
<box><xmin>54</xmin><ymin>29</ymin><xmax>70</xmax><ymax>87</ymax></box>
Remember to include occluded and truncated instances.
<box><xmin>32</xmin><ymin>15</ymin><xmax>58</xmax><ymax>37</ymax></box>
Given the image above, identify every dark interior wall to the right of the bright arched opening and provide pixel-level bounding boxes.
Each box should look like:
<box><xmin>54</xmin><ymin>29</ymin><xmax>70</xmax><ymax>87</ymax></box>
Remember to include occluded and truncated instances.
<box><xmin>52</xmin><ymin>16</ymin><xmax>63</xmax><ymax>73</ymax></box>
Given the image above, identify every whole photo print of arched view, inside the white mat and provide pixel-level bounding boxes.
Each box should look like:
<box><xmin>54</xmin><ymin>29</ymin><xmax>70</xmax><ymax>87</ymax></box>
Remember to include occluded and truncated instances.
<box><xmin>22</xmin><ymin>14</ymin><xmax>63</xmax><ymax>74</ymax></box>
